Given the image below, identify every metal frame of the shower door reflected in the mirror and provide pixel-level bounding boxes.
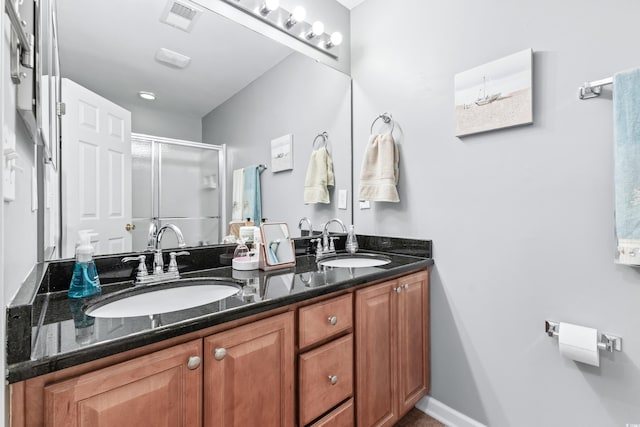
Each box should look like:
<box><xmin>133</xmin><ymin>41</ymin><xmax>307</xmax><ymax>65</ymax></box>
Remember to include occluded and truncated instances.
<box><xmin>131</xmin><ymin>132</ymin><xmax>227</xmax><ymax>247</ymax></box>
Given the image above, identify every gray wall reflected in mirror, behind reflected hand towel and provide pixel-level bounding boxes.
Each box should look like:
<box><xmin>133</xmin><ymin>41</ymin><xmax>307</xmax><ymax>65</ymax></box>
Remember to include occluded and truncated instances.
<box><xmin>203</xmin><ymin>53</ymin><xmax>351</xmax><ymax>235</ymax></box>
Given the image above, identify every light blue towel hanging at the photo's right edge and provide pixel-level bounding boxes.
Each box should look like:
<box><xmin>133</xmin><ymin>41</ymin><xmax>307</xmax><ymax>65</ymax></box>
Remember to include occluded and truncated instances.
<box><xmin>613</xmin><ymin>69</ymin><xmax>640</xmax><ymax>264</ymax></box>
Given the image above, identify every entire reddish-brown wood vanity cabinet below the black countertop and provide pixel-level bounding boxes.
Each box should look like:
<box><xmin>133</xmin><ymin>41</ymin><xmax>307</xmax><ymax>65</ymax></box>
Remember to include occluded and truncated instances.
<box><xmin>11</xmin><ymin>271</ymin><xmax>429</xmax><ymax>427</ymax></box>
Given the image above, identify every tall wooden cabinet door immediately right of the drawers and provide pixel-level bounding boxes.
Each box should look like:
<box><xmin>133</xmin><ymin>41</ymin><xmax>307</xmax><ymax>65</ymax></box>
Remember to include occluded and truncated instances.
<box><xmin>355</xmin><ymin>281</ymin><xmax>399</xmax><ymax>427</ymax></box>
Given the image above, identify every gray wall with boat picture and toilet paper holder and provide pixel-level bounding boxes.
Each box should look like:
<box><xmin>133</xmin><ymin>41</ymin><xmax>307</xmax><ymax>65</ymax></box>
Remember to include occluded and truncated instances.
<box><xmin>351</xmin><ymin>0</ymin><xmax>640</xmax><ymax>426</ymax></box>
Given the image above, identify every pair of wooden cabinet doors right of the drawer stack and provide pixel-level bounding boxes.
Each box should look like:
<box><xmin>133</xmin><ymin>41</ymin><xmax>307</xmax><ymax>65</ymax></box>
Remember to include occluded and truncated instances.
<box><xmin>355</xmin><ymin>272</ymin><xmax>429</xmax><ymax>427</ymax></box>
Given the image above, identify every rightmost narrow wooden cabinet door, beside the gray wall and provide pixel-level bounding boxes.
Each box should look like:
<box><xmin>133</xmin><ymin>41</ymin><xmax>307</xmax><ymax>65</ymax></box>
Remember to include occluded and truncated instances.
<box><xmin>398</xmin><ymin>273</ymin><xmax>429</xmax><ymax>417</ymax></box>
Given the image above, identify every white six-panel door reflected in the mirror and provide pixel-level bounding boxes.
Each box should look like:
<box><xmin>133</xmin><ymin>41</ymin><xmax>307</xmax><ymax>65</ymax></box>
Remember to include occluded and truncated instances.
<box><xmin>61</xmin><ymin>79</ymin><xmax>132</xmax><ymax>258</ymax></box>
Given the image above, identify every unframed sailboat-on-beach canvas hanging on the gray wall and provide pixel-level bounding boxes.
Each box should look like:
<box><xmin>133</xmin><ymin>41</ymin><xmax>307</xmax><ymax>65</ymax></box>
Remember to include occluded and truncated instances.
<box><xmin>454</xmin><ymin>49</ymin><xmax>533</xmax><ymax>136</ymax></box>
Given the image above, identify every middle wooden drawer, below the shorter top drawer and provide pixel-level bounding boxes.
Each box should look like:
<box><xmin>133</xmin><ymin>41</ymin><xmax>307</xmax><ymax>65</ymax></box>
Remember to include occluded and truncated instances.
<box><xmin>298</xmin><ymin>334</ymin><xmax>353</xmax><ymax>425</ymax></box>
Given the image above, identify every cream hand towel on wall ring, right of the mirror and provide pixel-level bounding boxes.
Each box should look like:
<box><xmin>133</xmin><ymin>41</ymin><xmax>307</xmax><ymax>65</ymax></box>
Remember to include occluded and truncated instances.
<box><xmin>358</xmin><ymin>133</ymin><xmax>400</xmax><ymax>202</ymax></box>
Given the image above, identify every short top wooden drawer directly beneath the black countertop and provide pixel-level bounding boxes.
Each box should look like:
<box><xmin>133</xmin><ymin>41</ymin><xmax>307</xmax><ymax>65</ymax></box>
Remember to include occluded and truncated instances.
<box><xmin>298</xmin><ymin>294</ymin><xmax>353</xmax><ymax>348</ymax></box>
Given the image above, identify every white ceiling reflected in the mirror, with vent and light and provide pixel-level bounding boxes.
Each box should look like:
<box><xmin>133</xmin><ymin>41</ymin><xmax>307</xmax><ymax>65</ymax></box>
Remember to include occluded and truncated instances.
<box><xmin>58</xmin><ymin>0</ymin><xmax>292</xmax><ymax>117</ymax></box>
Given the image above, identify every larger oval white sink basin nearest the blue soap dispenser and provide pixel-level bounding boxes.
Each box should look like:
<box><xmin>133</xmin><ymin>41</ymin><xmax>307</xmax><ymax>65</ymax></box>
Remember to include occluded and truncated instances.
<box><xmin>85</xmin><ymin>278</ymin><xmax>240</xmax><ymax>318</ymax></box>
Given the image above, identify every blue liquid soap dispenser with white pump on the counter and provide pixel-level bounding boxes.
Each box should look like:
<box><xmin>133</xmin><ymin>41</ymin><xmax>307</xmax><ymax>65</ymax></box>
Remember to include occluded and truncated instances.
<box><xmin>67</xmin><ymin>230</ymin><xmax>102</xmax><ymax>298</ymax></box>
